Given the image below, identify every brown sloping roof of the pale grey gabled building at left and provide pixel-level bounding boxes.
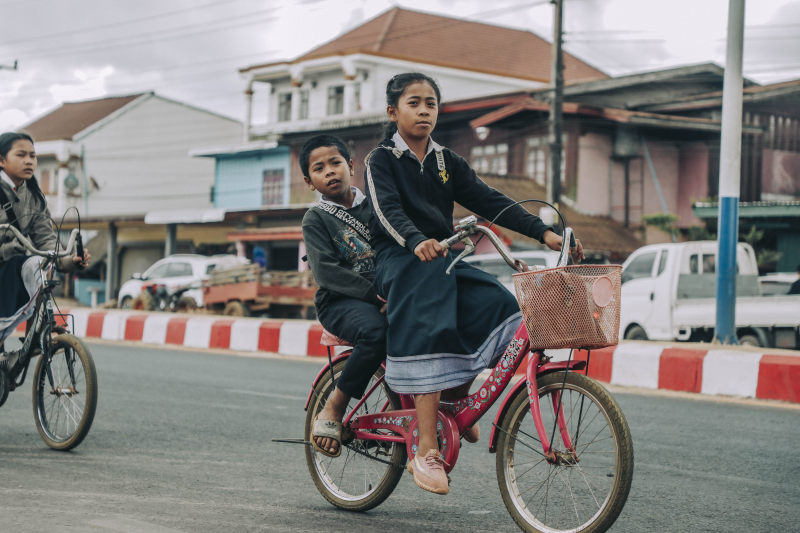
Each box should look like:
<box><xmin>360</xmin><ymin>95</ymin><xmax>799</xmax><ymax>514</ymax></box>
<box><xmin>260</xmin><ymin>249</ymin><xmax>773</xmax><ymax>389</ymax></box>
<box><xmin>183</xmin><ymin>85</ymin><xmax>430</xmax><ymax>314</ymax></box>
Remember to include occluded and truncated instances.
<box><xmin>22</xmin><ymin>94</ymin><xmax>142</xmax><ymax>142</ymax></box>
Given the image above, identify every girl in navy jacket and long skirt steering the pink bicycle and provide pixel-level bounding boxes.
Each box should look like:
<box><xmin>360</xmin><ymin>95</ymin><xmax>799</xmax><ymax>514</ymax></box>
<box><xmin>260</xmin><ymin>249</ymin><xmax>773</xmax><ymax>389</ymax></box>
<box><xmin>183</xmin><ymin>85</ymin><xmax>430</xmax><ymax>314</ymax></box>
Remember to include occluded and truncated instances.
<box><xmin>364</xmin><ymin>73</ymin><xmax>583</xmax><ymax>494</ymax></box>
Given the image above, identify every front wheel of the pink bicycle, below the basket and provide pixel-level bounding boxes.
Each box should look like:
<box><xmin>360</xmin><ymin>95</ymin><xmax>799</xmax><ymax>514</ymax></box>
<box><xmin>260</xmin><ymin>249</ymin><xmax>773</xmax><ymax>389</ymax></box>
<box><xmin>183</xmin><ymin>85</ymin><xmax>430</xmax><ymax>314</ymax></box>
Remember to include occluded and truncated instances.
<box><xmin>497</xmin><ymin>372</ymin><xmax>633</xmax><ymax>533</ymax></box>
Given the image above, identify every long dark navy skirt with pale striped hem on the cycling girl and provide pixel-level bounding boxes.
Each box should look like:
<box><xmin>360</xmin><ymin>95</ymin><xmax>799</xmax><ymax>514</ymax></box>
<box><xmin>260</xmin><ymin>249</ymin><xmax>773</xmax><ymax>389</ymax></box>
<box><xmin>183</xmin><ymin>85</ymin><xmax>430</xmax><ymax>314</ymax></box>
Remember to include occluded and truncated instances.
<box><xmin>377</xmin><ymin>245</ymin><xmax>521</xmax><ymax>394</ymax></box>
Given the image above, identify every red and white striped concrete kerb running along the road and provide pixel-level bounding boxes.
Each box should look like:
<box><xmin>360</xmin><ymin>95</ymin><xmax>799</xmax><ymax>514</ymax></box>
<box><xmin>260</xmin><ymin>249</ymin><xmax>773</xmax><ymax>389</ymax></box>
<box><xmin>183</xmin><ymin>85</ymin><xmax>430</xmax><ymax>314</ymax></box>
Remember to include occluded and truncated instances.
<box><xmin>28</xmin><ymin>308</ymin><xmax>800</xmax><ymax>403</ymax></box>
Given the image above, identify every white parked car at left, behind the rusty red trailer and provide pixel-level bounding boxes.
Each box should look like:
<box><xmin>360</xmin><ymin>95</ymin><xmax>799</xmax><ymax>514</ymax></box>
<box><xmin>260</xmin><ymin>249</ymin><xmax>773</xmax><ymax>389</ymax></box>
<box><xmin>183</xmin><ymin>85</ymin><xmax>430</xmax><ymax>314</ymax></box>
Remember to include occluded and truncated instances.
<box><xmin>117</xmin><ymin>254</ymin><xmax>248</xmax><ymax>309</ymax></box>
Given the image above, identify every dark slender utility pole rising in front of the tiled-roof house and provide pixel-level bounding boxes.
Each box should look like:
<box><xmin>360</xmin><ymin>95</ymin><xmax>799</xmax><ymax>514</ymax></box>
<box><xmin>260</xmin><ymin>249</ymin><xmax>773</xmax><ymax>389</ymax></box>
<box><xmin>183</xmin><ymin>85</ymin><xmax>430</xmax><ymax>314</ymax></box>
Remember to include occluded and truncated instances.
<box><xmin>547</xmin><ymin>0</ymin><xmax>564</xmax><ymax>212</ymax></box>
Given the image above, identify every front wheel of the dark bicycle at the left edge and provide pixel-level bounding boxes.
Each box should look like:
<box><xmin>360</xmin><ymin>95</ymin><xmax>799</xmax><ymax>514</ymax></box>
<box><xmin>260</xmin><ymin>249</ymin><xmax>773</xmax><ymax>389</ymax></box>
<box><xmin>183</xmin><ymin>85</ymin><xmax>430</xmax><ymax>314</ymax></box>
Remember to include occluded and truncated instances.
<box><xmin>33</xmin><ymin>334</ymin><xmax>97</xmax><ymax>451</ymax></box>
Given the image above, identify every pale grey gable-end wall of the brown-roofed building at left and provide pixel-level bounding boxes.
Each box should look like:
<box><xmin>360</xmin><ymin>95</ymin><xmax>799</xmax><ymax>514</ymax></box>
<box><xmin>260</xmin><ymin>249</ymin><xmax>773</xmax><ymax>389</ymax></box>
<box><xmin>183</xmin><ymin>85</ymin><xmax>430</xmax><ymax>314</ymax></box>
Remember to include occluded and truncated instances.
<box><xmin>76</xmin><ymin>97</ymin><xmax>241</xmax><ymax>216</ymax></box>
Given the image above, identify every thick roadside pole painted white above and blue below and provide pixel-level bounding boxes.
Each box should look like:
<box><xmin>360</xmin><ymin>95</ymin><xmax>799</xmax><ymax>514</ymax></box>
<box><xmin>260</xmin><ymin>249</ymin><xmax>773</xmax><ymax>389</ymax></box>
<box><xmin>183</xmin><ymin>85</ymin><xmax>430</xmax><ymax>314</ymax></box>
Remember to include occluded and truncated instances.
<box><xmin>714</xmin><ymin>0</ymin><xmax>745</xmax><ymax>344</ymax></box>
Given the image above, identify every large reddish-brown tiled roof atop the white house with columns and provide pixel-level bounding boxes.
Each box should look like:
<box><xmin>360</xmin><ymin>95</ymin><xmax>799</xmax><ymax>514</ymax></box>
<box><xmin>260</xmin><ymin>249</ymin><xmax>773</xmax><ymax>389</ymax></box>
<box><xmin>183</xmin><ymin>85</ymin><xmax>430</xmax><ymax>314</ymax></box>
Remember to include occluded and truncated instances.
<box><xmin>242</xmin><ymin>7</ymin><xmax>608</xmax><ymax>83</ymax></box>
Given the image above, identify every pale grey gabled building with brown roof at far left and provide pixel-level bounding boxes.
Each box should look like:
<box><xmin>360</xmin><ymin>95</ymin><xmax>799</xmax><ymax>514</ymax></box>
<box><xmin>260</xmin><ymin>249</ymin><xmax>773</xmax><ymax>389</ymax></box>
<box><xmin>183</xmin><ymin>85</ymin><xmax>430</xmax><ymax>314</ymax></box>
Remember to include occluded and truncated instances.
<box><xmin>21</xmin><ymin>92</ymin><xmax>241</xmax><ymax>296</ymax></box>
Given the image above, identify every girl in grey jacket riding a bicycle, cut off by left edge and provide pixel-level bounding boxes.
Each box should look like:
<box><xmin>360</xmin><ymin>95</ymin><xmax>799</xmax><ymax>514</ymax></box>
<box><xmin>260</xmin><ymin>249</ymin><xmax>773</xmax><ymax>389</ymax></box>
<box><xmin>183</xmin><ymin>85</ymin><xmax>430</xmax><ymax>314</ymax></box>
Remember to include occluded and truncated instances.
<box><xmin>0</xmin><ymin>132</ymin><xmax>90</xmax><ymax>351</ymax></box>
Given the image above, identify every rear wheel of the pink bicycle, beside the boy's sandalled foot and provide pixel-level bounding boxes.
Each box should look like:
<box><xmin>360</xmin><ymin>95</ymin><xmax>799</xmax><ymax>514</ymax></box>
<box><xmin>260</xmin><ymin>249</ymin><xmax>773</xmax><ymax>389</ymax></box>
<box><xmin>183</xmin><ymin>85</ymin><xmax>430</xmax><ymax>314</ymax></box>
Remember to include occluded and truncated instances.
<box><xmin>305</xmin><ymin>359</ymin><xmax>406</xmax><ymax>512</ymax></box>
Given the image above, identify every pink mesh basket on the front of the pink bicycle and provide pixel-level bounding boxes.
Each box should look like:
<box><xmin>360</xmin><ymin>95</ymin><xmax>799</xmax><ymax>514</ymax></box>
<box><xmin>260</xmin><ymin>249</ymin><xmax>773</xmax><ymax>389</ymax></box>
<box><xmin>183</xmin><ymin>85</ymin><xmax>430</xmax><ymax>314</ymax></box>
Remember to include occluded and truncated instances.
<box><xmin>513</xmin><ymin>265</ymin><xmax>622</xmax><ymax>349</ymax></box>
